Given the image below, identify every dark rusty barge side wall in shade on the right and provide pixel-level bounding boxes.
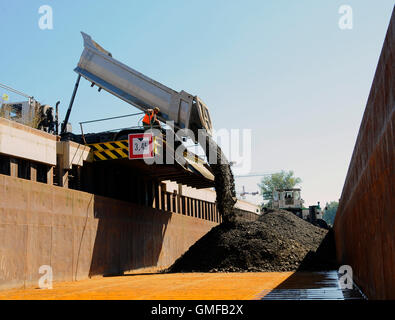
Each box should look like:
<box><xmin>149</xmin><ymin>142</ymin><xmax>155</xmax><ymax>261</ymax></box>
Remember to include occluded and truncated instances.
<box><xmin>334</xmin><ymin>9</ymin><xmax>395</xmax><ymax>299</ymax></box>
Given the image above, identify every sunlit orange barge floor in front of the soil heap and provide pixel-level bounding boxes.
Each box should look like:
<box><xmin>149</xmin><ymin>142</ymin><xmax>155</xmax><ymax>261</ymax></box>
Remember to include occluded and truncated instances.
<box><xmin>0</xmin><ymin>272</ymin><xmax>293</xmax><ymax>300</ymax></box>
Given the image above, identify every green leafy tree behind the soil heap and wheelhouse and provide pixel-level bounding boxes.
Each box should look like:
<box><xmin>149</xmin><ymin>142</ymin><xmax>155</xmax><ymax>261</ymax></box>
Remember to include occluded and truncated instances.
<box><xmin>258</xmin><ymin>170</ymin><xmax>302</xmax><ymax>205</ymax></box>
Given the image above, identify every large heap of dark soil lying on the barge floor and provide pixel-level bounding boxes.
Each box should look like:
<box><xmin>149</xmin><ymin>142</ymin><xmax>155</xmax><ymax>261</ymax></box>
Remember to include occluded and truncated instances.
<box><xmin>167</xmin><ymin>211</ymin><xmax>333</xmax><ymax>272</ymax></box>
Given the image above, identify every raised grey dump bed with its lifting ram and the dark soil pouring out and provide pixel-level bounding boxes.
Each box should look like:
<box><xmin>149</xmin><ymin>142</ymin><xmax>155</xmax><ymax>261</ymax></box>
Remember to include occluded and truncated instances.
<box><xmin>65</xmin><ymin>32</ymin><xmax>236</xmax><ymax>220</ymax></box>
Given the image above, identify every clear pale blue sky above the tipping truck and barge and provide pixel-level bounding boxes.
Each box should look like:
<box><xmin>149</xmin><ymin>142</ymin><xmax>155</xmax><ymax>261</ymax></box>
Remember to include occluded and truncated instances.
<box><xmin>0</xmin><ymin>0</ymin><xmax>394</xmax><ymax>204</ymax></box>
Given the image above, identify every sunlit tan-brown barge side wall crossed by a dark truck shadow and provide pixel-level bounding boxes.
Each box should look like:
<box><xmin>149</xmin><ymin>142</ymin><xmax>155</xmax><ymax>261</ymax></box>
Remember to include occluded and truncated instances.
<box><xmin>0</xmin><ymin>175</ymin><xmax>217</xmax><ymax>289</ymax></box>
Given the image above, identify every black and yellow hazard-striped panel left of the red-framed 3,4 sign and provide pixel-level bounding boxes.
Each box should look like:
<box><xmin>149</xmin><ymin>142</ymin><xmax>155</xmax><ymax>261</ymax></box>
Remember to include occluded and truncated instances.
<box><xmin>88</xmin><ymin>140</ymin><xmax>129</xmax><ymax>161</ymax></box>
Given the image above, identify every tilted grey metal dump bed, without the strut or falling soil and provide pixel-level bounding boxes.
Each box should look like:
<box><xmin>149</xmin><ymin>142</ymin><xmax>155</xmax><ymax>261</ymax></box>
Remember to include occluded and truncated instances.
<box><xmin>75</xmin><ymin>32</ymin><xmax>212</xmax><ymax>139</ymax></box>
